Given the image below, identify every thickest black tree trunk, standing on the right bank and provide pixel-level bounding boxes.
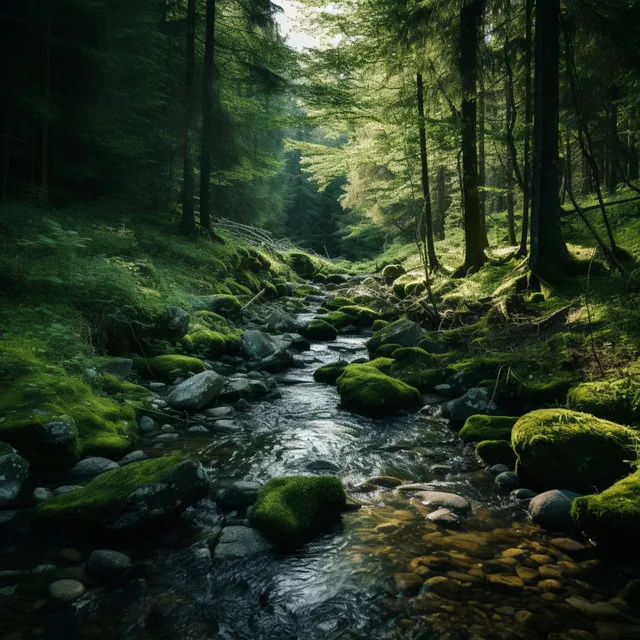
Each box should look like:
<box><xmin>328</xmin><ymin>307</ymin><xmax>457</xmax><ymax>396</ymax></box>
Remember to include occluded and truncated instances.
<box><xmin>530</xmin><ymin>0</ymin><xmax>568</xmax><ymax>277</ymax></box>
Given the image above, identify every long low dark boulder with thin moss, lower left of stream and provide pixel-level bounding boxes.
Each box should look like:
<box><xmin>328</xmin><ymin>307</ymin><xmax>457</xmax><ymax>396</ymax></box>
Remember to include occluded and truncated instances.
<box><xmin>35</xmin><ymin>456</ymin><xmax>210</xmax><ymax>534</ymax></box>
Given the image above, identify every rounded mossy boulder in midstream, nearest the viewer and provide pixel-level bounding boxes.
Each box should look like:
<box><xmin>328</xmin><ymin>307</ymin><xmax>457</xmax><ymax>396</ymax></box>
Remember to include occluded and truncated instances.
<box><xmin>251</xmin><ymin>476</ymin><xmax>346</xmax><ymax>547</ymax></box>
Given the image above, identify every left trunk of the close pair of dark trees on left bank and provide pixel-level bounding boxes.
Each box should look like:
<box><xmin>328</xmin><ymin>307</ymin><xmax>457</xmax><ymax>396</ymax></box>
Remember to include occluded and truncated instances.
<box><xmin>182</xmin><ymin>0</ymin><xmax>196</xmax><ymax>236</ymax></box>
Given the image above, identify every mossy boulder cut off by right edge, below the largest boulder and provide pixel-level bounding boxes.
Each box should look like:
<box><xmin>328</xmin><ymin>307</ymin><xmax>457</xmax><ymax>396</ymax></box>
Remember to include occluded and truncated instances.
<box><xmin>571</xmin><ymin>471</ymin><xmax>640</xmax><ymax>558</ymax></box>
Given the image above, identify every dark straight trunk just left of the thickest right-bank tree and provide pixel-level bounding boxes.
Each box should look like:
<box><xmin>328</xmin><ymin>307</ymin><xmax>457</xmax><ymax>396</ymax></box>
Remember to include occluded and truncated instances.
<box><xmin>460</xmin><ymin>0</ymin><xmax>486</xmax><ymax>271</ymax></box>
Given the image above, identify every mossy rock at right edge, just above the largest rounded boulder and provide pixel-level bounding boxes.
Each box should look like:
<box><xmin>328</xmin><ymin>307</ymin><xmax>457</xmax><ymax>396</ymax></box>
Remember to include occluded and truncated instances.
<box><xmin>567</xmin><ymin>378</ymin><xmax>640</xmax><ymax>425</ymax></box>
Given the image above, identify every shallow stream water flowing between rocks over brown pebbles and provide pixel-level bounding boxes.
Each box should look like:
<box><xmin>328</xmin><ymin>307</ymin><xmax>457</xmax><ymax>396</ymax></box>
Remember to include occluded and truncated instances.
<box><xmin>0</xmin><ymin>310</ymin><xmax>640</xmax><ymax>640</ymax></box>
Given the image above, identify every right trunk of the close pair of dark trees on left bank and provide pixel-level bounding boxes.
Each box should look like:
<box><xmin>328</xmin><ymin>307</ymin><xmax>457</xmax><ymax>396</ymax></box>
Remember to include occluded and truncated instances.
<box><xmin>200</xmin><ymin>0</ymin><xmax>216</xmax><ymax>231</ymax></box>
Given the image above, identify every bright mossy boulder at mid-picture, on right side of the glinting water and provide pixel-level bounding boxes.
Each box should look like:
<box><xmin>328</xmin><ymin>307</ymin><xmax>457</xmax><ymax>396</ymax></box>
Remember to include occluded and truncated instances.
<box><xmin>338</xmin><ymin>364</ymin><xmax>421</xmax><ymax>416</ymax></box>
